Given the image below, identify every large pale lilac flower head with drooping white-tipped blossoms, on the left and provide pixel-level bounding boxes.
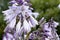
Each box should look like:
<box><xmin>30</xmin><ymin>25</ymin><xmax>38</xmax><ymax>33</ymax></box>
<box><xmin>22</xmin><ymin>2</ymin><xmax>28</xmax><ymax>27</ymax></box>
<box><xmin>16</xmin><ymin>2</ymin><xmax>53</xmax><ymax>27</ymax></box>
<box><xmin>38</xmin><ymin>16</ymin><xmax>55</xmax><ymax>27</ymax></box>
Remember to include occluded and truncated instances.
<box><xmin>2</xmin><ymin>0</ymin><xmax>38</xmax><ymax>39</ymax></box>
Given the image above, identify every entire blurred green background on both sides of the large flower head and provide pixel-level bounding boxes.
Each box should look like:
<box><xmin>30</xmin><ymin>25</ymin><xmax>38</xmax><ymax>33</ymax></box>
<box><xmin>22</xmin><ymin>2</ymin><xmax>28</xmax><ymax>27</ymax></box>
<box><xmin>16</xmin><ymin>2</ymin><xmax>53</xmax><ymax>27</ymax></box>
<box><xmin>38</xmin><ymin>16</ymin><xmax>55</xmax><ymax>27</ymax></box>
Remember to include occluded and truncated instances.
<box><xmin>0</xmin><ymin>0</ymin><xmax>60</xmax><ymax>40</ymax></box>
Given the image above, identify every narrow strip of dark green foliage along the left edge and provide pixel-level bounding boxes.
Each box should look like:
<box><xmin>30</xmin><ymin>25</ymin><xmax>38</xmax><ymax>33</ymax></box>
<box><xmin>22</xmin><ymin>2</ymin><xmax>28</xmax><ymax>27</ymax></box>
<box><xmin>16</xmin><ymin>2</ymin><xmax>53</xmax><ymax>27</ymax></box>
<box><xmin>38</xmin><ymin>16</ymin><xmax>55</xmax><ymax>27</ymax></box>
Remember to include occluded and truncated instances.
<box><xmin>0</xmin><ymin>0</ymin><xmax>8</xmax><ymax>40</ymax></box>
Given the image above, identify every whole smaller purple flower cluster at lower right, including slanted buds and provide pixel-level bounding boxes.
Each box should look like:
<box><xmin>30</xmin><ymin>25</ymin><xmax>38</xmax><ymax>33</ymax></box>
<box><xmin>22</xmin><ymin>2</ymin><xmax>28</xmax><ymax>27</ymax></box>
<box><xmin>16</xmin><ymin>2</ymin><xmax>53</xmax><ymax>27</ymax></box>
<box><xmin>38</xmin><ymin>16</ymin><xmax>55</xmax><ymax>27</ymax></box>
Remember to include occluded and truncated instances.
<box><xmin>29</xmin><ymin>17</ymin><xmax>59</xmax><ymax>40</ymax></box>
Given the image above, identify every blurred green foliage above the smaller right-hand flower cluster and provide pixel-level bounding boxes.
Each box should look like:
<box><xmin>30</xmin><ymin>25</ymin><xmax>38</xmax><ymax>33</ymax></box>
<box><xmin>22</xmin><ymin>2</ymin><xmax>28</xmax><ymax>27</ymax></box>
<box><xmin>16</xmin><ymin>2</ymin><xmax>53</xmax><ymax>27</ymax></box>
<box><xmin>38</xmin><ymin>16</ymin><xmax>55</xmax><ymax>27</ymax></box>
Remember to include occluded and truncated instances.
<box><xmin>31</xmin><ymin>0</ymin><xmax>60</xmax><ymax>34</ymax></box>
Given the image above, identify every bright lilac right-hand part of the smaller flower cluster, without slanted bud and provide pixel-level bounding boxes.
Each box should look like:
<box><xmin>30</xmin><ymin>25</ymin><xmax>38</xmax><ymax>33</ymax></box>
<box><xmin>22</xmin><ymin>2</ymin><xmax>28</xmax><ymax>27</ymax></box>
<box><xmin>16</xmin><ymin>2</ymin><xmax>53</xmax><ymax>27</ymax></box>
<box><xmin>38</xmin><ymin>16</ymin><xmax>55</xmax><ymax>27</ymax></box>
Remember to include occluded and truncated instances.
<box><xmin>43</xmin><ymin>20</ymin><xmax>59</xmax><ymax>40</ymax></box>
